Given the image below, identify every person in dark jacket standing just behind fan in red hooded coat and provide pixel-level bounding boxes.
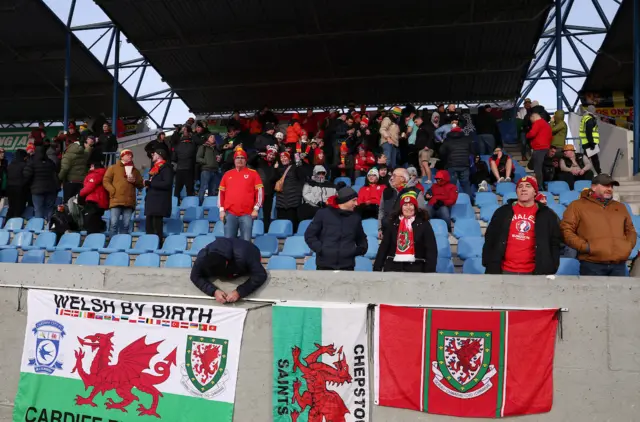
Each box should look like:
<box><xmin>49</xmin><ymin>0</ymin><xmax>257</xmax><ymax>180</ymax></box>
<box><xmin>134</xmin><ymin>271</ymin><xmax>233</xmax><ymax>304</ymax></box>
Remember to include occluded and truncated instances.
<box><xmin>440</xmin><ymin>126</ymin><xmax>475</xmax><ymax>197</ymax></box>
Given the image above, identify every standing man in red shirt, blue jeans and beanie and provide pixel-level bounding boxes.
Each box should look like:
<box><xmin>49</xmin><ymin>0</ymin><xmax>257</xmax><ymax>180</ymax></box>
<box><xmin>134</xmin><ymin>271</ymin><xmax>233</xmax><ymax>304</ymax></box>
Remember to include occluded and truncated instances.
<box><xmin>218</xmin><ymin>148</ymin><xmax>262</xmax><ymax>241</ymax></box>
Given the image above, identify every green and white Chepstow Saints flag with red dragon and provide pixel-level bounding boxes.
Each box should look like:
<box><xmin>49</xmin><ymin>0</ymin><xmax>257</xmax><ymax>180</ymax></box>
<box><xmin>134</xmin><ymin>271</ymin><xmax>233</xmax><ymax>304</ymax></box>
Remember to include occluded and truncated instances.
<box><xmin>272</xmin><ymin>302</ymin><xmax>369</xmax><ymax>422</ymax></box>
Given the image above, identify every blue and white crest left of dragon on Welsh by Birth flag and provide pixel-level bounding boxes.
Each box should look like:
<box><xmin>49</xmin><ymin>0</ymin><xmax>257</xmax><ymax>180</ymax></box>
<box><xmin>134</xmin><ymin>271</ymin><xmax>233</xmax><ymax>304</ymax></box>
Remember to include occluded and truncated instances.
<box><xmin>29</xmin><ymin>320</ymin><xmax>65</xmax><ymax>374</ymax></box>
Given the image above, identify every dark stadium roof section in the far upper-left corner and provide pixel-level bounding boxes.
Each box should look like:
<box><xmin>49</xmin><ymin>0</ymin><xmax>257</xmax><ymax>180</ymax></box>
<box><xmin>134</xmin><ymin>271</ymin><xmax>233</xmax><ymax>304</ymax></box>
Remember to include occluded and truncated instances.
<box><xmin>0</xmin><ymin>0</ymin><xmax>147</xmax><ymax>123</ymax></box>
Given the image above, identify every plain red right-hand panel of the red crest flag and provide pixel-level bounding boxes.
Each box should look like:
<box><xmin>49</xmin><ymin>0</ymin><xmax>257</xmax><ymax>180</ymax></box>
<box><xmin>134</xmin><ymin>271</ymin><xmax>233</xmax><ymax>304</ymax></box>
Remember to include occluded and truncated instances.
<box><xmin>503</xmin><ymin>309</ymin><xmax>558</xmax><ymax>416</ymax></box>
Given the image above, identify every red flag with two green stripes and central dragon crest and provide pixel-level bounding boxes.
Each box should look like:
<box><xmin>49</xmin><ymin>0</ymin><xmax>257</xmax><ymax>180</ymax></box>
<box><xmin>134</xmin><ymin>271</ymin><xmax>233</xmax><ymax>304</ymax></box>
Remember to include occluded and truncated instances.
<box><xmin>374</xmin><ymin>305</ymin><xmax>558</xmax><ymax>418</ymax></box>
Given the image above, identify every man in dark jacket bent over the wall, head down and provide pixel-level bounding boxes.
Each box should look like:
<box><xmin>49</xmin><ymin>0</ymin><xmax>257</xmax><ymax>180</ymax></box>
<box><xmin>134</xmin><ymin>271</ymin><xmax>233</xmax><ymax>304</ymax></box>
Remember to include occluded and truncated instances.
<box><xmin>191</xmin><ymin>237</ymin><xmax>267</xmax><ymax>303</ymax></box>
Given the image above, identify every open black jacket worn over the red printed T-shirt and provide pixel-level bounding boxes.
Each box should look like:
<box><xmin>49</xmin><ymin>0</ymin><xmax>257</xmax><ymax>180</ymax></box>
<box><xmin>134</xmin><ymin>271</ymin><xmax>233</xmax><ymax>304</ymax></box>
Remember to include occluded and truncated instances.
<box><xmin>482</xmin><ymin>199</ymin><xmax>562</xmax><ymax>275</ymax></box>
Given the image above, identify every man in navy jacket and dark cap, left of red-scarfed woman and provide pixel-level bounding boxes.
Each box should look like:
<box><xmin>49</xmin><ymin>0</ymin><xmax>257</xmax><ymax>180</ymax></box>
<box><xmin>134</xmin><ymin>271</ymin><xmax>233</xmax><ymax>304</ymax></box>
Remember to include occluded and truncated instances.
<box><xmin>304</xmin><ymin>187</ymin><xmax>368</xmax><ymax>271</ymax></box>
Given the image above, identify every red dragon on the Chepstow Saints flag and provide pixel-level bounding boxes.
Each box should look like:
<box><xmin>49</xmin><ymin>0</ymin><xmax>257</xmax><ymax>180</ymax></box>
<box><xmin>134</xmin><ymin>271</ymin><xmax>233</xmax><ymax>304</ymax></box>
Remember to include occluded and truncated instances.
<box><xmin>291</xmin><ymin>344</ymin><xmax>353</xmax><ymax>422</ymax></box>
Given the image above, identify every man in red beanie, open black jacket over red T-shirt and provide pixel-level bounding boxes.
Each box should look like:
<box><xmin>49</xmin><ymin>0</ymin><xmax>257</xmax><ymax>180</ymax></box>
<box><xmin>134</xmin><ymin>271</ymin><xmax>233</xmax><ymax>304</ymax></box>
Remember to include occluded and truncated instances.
<box><xmin>482</xmin><ymin>176</ymin><xmax>562</xmax><ymax>275</ymax></box>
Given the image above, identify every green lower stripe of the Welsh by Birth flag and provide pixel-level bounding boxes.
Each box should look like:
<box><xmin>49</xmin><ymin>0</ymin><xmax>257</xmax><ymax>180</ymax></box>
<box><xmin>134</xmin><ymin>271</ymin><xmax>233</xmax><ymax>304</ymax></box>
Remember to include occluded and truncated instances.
<box><xmin>13</xmin><ymin>372</ymin><xmax>233</xmax><ymax>422</ymax></box>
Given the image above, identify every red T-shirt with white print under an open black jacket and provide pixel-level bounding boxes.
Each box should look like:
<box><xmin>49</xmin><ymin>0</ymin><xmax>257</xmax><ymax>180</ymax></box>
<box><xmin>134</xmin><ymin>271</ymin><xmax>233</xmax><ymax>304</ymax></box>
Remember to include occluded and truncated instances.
<box><xmin>502</xmin><ymin>203</ymin><xmax>538</xmax><ymax>273</ymax></box>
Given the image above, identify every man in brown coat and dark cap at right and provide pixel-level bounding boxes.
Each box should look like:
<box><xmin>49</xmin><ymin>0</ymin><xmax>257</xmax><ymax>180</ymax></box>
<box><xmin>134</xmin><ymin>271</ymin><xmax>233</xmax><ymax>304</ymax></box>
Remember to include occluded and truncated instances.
<box><xmin>560</xmin><ymin>173</ymin><xmax>636</xmax><ymax>277</ymax></box>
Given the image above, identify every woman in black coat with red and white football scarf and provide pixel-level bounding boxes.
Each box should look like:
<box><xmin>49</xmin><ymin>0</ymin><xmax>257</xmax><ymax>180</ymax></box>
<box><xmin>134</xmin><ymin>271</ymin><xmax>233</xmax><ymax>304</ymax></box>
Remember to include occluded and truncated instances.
<box><xmin>373</xmin><ymin>191</ymin><xmax>438</xmax><ymax>273</ymax></box>
